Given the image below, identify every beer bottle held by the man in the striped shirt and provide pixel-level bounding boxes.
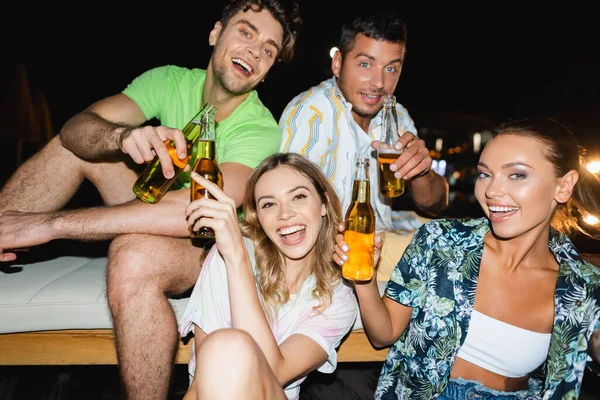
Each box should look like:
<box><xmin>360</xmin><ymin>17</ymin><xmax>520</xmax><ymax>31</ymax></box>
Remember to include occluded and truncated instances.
<box><xmin>377</xmin><ymin>95</ymin><xmax>404</xmax><ymax>198</ymax></box>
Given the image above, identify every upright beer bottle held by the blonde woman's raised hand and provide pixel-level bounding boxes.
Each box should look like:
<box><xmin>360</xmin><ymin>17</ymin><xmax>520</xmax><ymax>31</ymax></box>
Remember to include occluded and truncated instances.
<box><xmin>190</xmin><ymin>104</ymin><xmax>223</xmax><ymax>239</ymax></box>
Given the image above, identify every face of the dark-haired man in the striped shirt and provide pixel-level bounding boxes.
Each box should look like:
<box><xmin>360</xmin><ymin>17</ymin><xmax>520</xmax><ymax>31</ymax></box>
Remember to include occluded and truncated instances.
<box><xmin>331</xmin><ymin>34</ymin><xmax>406</xmax><ymax>129</ymax></box>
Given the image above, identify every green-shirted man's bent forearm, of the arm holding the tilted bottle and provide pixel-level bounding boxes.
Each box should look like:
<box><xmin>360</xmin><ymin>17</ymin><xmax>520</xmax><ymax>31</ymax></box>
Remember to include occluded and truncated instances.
<box><xmin>59</xmin><ymin>111</ymin><xmax>132</xmax><ymax>160</ymax></box>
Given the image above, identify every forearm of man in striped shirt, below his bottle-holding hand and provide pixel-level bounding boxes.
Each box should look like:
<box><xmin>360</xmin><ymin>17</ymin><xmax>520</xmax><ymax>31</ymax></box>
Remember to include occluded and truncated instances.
<box><xmin>410</xmin><ymin>170</ymin><xmax>449</xmax><ymax>214</ymax></box>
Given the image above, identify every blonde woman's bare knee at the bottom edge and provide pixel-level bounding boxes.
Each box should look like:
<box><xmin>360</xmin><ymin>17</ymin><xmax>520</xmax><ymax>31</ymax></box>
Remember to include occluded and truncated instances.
<box><xmin>190</xmin><ymin>329</ymin><xmax>287</xmax><ymax>400</ymax></box>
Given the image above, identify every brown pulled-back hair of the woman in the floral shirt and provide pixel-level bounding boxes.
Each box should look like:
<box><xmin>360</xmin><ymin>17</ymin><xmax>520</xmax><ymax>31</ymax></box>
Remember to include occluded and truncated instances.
<box><xmin>495</xmin><ymin>118</ymin><xmax>600</xmax><ymax>236</ymax></box>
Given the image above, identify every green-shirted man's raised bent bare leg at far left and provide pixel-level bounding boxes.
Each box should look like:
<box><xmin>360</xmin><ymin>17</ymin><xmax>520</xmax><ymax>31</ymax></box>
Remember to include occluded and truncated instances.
<box><xmin>0</xmin><ymin>135</ymin><xmax>137</xmax><ymax>212</ymax></box>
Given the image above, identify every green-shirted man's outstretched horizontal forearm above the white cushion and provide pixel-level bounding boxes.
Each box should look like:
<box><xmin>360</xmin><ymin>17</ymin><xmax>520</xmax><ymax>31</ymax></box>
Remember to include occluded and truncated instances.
<box><xmin>50</xmin><ymin>189</ymin><xmax>189</xmax><ymax>241</ymax></box>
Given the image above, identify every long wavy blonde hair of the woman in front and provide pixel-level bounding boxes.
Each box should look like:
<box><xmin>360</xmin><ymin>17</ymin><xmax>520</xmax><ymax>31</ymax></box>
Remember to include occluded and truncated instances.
<box><xmin>240</xmin><ymin>153</ymin><xmax>343</xmax><ymax>321</ymax></box>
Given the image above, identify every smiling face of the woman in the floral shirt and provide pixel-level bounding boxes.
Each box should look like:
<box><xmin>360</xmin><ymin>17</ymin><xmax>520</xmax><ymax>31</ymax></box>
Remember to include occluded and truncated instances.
<box><xmin>475</xmin><ymin>134</ymin><xmax>567</xmax><ymax>239</ymax></box>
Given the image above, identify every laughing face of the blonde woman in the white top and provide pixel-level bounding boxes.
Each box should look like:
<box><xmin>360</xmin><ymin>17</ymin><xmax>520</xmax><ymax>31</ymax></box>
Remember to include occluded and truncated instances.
<box><xmin>254</xmin><ymin>166</ymin><xmax>327</xmax><ymax>263</ymax></box>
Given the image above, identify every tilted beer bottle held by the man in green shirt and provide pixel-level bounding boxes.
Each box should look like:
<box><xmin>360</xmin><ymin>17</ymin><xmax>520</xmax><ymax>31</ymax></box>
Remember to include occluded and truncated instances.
<box><xmin>133</xmin><ymin>103</ymin><xmax>216</xmax><ymax>203</ymax></box>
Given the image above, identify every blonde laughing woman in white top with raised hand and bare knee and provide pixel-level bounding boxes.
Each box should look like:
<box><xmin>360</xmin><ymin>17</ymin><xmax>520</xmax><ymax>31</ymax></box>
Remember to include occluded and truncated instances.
<box><xmin>180</xmin><ymin>153</ymin><xmax>358</xmax><ymax>400</ymax></box>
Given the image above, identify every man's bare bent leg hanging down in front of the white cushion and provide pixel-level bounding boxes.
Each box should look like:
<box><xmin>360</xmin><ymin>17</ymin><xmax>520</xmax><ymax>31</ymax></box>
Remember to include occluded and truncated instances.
<box><xmin>108</xmin><ymin>234</ymin><xmax>203</xmax><ymax>400</ymax></box>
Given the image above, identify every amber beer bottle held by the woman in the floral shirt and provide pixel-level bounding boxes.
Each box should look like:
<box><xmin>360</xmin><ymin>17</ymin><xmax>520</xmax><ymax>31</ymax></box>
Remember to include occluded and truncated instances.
<box><xmin>342</xmin><ymin>158</ymin><xmax>375</xmax><ymax>281</ymax></box>
